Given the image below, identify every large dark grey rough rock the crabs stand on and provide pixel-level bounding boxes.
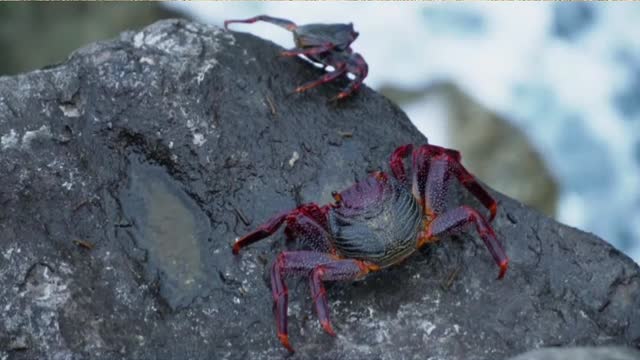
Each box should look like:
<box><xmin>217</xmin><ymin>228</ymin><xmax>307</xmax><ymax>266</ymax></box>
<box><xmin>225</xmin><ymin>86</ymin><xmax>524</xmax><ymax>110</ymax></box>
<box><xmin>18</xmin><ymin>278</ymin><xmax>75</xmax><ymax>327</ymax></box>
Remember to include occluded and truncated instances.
<box><xmin>0</xmin><ymin>21</ymin><xmax>640</xmax><ymax>360</ymax></box>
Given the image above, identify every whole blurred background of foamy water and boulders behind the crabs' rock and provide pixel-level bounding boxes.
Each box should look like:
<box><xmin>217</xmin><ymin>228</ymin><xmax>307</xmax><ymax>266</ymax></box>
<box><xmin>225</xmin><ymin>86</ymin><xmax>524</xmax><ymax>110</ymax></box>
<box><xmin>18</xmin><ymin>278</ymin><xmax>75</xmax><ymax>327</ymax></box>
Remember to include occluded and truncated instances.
<box><xmin>0</xmin><ymin>2</ymin><xmax>640</xmax><ymax>262</ymax></box>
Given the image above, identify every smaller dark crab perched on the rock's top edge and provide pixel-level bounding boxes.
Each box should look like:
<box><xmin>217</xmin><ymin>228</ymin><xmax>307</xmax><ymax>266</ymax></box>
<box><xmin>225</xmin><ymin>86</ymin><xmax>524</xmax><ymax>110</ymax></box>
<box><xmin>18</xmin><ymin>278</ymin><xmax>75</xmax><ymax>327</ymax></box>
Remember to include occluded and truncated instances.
<box><xmin>224</xmin><ymin>15</ymin><xmax>369</xmax><ymax>101</ymax></box>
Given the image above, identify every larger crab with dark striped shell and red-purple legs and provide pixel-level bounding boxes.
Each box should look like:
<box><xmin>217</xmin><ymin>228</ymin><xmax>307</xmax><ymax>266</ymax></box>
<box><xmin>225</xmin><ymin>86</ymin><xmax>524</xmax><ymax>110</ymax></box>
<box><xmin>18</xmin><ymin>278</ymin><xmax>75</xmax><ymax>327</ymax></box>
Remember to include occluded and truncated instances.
<box><xmin>233</xmin><ymin>144</ymin><xmax>509</xmax><ymax>352</ymax></box>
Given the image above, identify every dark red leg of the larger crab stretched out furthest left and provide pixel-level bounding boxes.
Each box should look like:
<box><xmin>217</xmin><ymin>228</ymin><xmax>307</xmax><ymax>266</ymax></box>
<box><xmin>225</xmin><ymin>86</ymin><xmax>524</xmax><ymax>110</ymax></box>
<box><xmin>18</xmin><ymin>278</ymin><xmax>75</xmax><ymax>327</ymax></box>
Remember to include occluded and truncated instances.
<box><xmin>233</xmin><ymin>204</ymin><xmax>328</xmax><ymax>255</ymax></box>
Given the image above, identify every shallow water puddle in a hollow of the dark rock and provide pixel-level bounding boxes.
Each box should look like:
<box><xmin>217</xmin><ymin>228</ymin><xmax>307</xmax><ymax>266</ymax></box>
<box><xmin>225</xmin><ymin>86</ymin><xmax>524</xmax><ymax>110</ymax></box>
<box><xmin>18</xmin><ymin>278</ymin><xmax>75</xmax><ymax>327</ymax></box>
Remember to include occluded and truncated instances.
<box><xmin>121</xmin><ymin>162</ymin><xmax>213</xmax><ymax>309</ymax></box>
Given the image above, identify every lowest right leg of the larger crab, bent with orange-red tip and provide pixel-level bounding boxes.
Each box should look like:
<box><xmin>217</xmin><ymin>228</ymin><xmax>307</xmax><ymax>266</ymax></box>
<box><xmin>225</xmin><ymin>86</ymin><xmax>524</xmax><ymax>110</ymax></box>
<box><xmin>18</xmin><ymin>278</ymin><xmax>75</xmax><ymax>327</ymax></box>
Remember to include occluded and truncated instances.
<box><xmin>420</xmin><ymin>206</ymin><xmax>509</xmax><ymax>279</ymax></box>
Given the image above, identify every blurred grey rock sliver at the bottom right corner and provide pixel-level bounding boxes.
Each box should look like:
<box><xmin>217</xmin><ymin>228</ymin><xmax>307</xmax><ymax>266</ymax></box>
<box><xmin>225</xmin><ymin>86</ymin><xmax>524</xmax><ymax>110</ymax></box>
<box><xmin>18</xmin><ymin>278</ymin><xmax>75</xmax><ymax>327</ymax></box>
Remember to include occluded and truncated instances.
<box><xmin>511</xmin><ymin>346</ymin><xmax>640</xmax><ymax>360</ymax></box>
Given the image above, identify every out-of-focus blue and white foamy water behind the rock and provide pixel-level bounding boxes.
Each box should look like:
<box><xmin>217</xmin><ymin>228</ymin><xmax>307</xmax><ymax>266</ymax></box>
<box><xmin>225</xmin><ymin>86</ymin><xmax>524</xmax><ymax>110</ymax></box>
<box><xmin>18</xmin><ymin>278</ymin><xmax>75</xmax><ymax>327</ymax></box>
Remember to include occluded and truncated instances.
<box><xmin>169</xmin><ymin>2</ymin><xmax>640</xmax><ymax>262</ymax></box>
